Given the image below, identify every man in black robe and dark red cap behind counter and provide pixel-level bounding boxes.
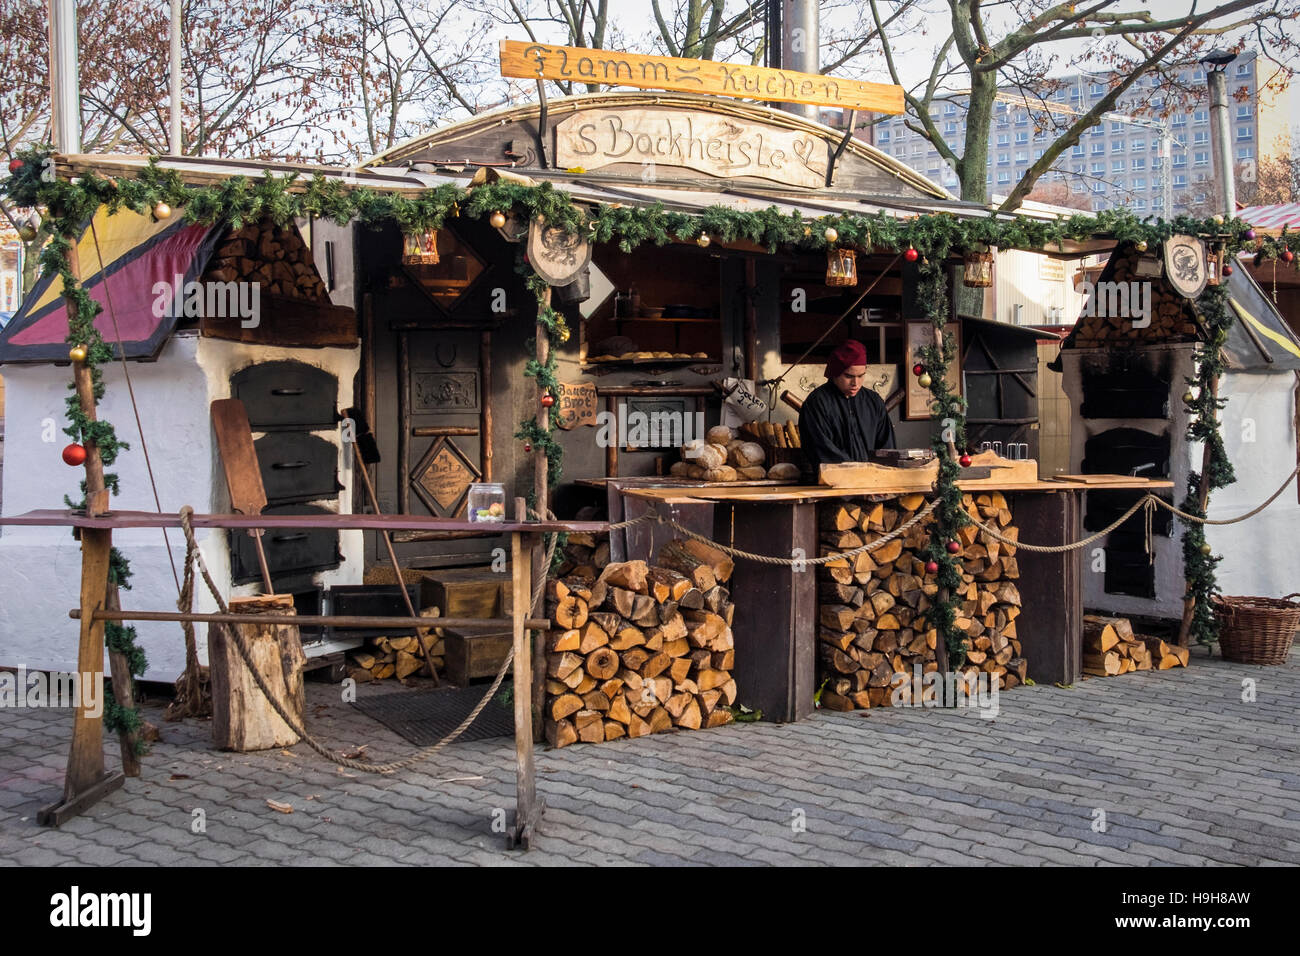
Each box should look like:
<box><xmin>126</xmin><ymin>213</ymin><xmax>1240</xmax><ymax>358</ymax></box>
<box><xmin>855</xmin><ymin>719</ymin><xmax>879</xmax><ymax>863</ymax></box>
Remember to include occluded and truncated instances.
<box><xmin>800</xmin><ymin>338</ymin><xmax>894</xmax><ymax>471</ymax></box>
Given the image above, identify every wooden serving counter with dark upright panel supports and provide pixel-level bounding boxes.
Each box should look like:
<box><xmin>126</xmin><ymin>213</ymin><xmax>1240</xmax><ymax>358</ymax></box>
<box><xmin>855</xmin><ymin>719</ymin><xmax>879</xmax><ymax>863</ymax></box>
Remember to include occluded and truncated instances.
<box><xmin>607</xmin><ymin>476</ymin><xmax>1174</xmax><ymax>722</ymax></box>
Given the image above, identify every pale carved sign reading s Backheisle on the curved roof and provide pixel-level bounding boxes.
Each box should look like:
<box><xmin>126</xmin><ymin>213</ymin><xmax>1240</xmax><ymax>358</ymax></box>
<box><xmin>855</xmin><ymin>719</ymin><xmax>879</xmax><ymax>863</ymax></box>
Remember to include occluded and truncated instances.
<box><xmin>555</xmin><ymin>109</ymin><xmax>827</xmax><ymax>189</ymax></box>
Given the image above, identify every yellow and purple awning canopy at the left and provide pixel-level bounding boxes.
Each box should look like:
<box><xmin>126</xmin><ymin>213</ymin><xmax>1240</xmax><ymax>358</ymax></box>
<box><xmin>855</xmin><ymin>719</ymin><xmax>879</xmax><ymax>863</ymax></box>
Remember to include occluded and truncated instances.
<box><xmin>0</xmin><ymin>208</ymin><xmax>221</xmax><ymax>364</ymax></box>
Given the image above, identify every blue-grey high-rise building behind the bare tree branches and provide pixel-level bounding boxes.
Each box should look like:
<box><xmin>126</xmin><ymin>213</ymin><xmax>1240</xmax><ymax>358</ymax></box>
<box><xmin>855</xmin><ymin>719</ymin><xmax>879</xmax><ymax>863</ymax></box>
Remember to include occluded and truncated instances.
<box><xmin>859</xmin><ymin>51</ymin><xmax>1291</xmax><ymax>219</ymax></box>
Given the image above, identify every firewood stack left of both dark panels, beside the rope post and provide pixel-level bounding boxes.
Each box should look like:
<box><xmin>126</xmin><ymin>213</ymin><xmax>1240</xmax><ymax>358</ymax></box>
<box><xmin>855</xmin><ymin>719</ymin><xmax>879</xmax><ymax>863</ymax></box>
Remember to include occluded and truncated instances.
<box><xmin>545</xmin><ymin>541</ymin><xmax>736</xmax><ymax>747</ymax></box>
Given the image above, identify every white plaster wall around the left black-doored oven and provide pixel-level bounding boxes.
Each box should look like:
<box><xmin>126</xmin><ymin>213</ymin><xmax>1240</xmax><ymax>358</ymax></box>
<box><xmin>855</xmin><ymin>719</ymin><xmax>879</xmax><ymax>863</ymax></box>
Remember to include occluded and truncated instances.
<box><xmin>0</xmin><ymin>334</ymin><xmax>363</xmax><ymax>682</ymax></box>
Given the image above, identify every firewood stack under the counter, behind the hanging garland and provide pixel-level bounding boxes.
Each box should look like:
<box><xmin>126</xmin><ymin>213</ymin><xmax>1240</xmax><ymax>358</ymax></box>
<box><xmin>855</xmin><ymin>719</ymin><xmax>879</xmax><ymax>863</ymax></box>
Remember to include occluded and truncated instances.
<box><xmin>818</xmin><ymin>492</ymin><xmax>1027</xmax><ymax>710</ymax></box>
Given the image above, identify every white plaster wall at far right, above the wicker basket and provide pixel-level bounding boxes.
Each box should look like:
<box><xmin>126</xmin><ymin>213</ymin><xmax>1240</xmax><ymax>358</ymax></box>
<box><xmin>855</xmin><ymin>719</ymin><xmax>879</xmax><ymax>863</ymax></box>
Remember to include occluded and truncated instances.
<box><xmin>1188</xmin><ymin>372</ymin><xmax>1300</xmax><ymax>597</ymax></box>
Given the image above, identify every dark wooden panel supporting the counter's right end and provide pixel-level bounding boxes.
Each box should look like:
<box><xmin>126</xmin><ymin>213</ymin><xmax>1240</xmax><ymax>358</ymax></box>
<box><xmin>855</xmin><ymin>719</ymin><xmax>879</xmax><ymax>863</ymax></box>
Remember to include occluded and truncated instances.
<box><xmin>1011</xmin><ymin>490</ymin><xmax>1089</xmax><ymax>684</ymax></box>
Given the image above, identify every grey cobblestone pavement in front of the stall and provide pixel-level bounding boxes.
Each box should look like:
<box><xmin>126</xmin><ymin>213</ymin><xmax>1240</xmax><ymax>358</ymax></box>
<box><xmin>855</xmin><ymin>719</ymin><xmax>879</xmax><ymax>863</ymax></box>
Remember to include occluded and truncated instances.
<box><xmin>0</xmin><ymin>649</ymin><xmax>1300</xmax><ymax>866</ymax></box>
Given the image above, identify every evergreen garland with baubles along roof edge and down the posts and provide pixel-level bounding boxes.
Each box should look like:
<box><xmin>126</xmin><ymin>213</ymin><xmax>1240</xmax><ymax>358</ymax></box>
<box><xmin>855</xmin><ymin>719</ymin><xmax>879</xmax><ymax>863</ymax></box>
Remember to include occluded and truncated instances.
<box><xmin>0</xmin><ymin>147</ymin><xmax>1263</xmax><ymax>697</ymax></box>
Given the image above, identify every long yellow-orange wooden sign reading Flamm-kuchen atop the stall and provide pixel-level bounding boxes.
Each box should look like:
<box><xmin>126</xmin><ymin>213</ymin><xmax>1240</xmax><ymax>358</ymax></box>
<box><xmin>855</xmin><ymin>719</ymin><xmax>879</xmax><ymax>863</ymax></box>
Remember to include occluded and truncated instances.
<box><xmin>501</xmin><ymin>40</ymin><xmax>904</xmax><ymax>114</ymax></box>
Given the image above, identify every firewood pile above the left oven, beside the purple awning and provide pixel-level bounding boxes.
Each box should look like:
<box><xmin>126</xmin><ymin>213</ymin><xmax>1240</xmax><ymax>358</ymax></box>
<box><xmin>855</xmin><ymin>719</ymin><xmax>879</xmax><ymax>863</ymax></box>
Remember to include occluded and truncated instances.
<box><xmin>203</xmin><ymin>220</ymin><xmax>329</xmax><ymax>302</ymax></box>
